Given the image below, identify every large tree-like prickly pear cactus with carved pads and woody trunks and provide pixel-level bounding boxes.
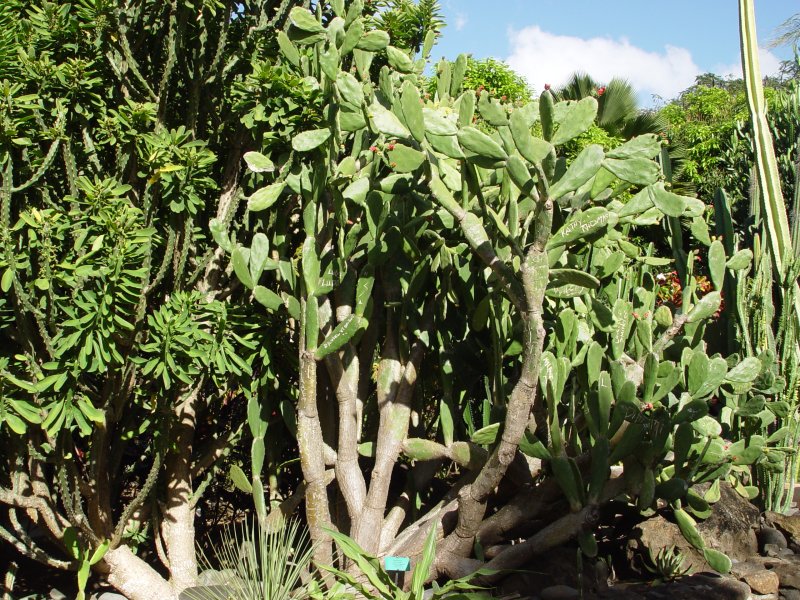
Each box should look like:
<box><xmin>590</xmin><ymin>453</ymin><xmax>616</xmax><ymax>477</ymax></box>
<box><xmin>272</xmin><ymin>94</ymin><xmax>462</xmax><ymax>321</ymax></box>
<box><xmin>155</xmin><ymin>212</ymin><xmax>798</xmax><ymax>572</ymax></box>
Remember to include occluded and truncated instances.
<box><xmin>223</xmin><ymin>0</ymin><xmax>761</xmax><ymax>580</ymax></box>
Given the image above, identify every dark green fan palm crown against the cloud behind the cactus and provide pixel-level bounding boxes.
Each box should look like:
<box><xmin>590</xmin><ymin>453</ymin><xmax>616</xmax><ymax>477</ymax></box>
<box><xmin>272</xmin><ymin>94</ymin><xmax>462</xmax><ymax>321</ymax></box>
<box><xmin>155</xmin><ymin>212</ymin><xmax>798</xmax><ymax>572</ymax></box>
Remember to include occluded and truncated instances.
<box><xmin>555</xmin><ymin>72</ymin><xmax>666</xmax><ymax>140</ymax></box>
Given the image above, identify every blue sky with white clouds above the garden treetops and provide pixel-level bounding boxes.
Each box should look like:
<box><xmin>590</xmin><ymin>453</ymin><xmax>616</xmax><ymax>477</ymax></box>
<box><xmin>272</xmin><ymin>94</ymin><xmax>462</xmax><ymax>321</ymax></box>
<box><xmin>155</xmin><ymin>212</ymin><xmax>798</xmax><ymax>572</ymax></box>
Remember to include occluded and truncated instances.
<box><xmin>433</xmin><ymin>0</ymin><xmax>800</xmax><ymax>105</ymax></box>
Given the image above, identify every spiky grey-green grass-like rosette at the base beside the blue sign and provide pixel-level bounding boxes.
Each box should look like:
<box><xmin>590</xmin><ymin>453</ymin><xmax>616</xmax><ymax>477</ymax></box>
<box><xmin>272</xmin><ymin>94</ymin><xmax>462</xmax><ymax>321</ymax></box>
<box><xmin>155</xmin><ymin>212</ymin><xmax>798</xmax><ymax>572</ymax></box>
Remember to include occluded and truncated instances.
<box><xmin>181</xmin><ymin>519</ymin><xmax>313</xmax><ymax>600</ymax></box>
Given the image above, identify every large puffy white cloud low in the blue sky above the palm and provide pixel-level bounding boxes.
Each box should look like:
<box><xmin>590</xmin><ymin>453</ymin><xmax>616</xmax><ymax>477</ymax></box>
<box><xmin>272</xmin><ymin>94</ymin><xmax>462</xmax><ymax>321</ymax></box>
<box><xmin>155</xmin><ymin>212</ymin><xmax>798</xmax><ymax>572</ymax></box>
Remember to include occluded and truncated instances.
<box><xmin>507</xmin><ymin>26</ymin><xmax>701</xmax><ymax>99</ymax></box>
